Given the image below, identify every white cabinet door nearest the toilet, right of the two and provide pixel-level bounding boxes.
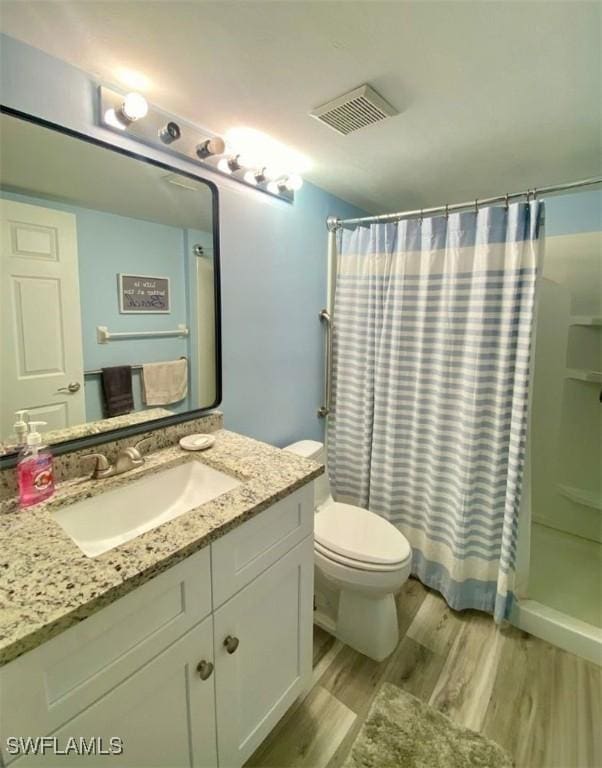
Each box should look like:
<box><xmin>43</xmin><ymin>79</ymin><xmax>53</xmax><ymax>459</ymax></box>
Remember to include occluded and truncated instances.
<box><xmin>214</xmin><ymin>536</ymin><xmax>313</xmax><ymax>768</ymax></box>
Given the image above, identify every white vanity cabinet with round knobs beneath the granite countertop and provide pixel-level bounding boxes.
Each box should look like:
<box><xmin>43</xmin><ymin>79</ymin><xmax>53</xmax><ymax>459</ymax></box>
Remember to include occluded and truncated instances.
<box><xmin>0</xmin><ymin>484</ymin><xmax>313</xmax><ymax>768</ymax></box>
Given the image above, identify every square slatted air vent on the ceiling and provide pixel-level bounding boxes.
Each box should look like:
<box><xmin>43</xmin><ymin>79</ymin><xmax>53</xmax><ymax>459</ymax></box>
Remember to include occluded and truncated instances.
<box><xmin>310</xmin><ymin>85</ymin><xmax>399</xmax><ymax>136</ymax></box>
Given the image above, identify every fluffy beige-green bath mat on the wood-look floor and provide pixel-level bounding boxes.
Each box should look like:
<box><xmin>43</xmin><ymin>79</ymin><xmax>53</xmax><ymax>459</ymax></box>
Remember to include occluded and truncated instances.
<box><xmin>344</xmin><ymin>683</ymin><xmax>514</xmax><ymax>768</ymax></box>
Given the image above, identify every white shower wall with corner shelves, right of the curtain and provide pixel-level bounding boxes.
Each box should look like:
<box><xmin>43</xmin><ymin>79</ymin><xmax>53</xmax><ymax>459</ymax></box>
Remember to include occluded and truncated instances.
<box><xmin>531</xmin><ymin>232</ymin><xmax>602</xmax><ymax>542</ymax></box>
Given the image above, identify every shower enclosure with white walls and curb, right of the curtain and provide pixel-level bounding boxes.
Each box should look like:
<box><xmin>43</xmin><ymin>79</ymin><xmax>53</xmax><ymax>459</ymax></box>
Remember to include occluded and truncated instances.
<box><xmin>513</xmin><ymin>193</ymin><xmax>602</xmax><ymax>663</ymax></box>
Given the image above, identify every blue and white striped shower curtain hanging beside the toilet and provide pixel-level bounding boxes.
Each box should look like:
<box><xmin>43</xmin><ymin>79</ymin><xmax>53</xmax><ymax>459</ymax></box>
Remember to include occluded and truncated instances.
<box><xmin>328</xmin><ymin>202</ymin><xmax>543</xmax><ymax>621</ymax></box>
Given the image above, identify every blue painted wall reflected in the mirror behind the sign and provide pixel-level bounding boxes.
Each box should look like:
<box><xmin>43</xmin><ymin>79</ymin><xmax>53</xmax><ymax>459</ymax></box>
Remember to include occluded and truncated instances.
<box><xmin>2</xmin><ymin>191</ymin><xmax>197</xmax><ymax>421</ymax></box>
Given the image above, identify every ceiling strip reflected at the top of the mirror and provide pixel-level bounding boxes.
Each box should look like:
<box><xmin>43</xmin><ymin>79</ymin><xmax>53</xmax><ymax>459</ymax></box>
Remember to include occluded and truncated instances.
<box><xmin>0</xmin><ymin>115</ymin><xmax>213</xmax><ymax>232</ymax></box>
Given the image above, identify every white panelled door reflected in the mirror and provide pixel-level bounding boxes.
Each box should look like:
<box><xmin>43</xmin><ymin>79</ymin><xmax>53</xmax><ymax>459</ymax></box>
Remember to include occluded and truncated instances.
<box><xmin>0</xmin><ymin>199</ymin><xmax>86</xmax><ymax>440</ymax></box>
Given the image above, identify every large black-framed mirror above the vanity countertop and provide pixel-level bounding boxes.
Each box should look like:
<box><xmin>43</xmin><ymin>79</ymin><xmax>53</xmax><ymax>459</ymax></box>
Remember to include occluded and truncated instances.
<box><xmin>0</xmin><ymin>109</ymin><xmax>221</xmax><ymax>457</ymax></box>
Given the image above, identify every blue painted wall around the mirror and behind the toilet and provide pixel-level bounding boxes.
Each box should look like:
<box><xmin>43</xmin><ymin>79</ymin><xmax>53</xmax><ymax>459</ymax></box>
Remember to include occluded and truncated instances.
<box><xmin>0</xmin><ymin>36</ymin><xmax>362</xmax><ymax>445</ymax></box>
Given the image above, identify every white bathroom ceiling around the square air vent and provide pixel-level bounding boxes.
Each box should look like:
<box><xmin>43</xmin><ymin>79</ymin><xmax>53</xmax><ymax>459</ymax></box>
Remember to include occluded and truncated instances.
<box><xmin>1</xmin><ymin>0</ymin><xmax>602</xmax><ymax>212</ymax></box>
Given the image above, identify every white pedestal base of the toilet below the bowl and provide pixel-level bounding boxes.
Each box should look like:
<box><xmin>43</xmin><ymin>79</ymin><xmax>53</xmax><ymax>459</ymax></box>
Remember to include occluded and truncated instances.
<box><xmin>314</xmin><ymin>573</ymin><xmax>399</xmax><ymax>661</ymax></box>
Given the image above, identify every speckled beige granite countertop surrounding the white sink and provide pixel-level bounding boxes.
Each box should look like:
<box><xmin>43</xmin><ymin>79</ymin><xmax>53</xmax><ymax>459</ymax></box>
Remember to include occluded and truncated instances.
<box><xmin>0</xmin><ymin>430</ymin><xmax>324</xmax><ymax>666</ymax></box>
